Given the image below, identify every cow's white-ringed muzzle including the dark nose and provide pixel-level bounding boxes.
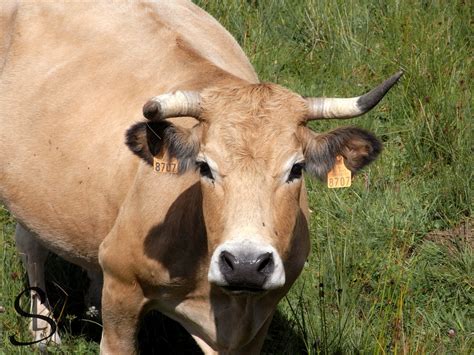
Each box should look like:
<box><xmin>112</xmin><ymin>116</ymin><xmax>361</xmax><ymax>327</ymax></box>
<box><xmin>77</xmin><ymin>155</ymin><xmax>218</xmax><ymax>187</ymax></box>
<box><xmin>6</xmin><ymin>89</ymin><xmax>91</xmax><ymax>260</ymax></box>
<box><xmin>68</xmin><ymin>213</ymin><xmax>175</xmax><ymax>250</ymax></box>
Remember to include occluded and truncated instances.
<box><xmin>208</xmin><ymin>240</ymin><xmax>285</xmax><ymax>294</ymax></box>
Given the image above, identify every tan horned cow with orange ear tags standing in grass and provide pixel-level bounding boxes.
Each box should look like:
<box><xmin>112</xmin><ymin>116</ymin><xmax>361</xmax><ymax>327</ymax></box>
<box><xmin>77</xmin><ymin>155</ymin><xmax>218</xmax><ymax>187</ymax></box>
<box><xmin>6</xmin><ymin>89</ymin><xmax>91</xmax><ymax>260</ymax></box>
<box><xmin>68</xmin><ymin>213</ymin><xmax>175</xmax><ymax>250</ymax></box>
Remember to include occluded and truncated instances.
<box><xmin>0</xmin><ymin>0</ymin><xmax>401</xmax><ymax>354</ymax></box>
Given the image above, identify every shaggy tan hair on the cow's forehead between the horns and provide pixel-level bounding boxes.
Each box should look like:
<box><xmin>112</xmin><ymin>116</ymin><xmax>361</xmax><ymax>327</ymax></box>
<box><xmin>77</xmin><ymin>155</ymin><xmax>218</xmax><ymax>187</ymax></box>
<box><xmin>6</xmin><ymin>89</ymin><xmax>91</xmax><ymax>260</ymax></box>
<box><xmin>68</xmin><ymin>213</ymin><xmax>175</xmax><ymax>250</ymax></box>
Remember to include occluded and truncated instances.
<box><xmin>202</xmin><ymin>83</ymin><xmax>307</xmax><ymax>161</ymax></box>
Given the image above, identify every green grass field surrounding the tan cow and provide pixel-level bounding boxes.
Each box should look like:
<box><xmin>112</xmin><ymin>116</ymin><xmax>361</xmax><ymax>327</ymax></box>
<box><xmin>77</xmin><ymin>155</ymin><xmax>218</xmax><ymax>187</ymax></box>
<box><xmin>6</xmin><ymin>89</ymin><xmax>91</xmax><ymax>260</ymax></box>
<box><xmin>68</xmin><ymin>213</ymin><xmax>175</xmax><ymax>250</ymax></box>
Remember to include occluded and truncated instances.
<box><xmin>0</xmin><ymin>0</ymin><xmax>474</xmax><ymax>354</ymax></box>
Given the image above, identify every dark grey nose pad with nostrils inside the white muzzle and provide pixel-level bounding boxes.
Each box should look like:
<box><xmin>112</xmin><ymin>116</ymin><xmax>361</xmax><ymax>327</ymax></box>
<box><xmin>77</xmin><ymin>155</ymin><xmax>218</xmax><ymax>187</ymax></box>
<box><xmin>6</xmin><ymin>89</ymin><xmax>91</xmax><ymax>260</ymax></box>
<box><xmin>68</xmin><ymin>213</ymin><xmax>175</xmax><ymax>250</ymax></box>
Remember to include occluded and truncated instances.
<box><xmin>219</xmin><ymin>251</ymin><xmax>275</xmax><ymax>291</ymax></box>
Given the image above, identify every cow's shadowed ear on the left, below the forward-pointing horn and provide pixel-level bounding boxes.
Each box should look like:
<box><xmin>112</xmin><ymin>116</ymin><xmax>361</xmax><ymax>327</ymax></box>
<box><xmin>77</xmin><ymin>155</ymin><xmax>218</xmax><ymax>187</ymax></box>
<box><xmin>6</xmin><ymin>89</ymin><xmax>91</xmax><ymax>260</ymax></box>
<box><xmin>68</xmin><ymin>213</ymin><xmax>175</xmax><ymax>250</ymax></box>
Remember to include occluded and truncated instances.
<box><xmin>125</xmin><ymin>120</ymin><xmax>199</xmax><ymax>173</ymax></box>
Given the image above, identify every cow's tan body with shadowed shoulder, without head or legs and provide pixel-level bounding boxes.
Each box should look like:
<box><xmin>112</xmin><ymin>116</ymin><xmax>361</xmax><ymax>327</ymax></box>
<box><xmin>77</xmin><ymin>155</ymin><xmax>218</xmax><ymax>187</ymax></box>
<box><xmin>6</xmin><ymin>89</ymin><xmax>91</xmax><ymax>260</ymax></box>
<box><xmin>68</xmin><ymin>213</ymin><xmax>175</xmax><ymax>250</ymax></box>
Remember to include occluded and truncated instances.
<box><xmin>0</xmin><ymin>1</ymin><xmax>298</xmax><ymax>354</ymax></box>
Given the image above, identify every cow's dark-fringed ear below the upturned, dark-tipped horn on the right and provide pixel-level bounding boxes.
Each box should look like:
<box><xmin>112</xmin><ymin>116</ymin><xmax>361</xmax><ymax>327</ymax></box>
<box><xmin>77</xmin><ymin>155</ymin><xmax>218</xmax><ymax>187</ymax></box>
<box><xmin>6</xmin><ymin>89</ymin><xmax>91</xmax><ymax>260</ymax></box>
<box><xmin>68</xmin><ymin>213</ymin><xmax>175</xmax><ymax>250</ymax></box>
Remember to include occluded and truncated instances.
<box><xmin>302</xmin><ymin>127</ymin><xmax>382</xmax><ymax>181</ymax></box>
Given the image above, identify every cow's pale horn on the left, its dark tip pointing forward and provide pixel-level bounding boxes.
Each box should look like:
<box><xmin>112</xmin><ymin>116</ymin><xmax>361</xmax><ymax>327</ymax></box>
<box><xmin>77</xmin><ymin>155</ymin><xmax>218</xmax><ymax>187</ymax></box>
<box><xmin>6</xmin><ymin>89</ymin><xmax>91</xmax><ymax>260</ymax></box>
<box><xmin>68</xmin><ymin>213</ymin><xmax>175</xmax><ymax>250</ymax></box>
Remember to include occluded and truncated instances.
<box><xmin>143</xmin><ymin>91</ymin><xmax>201</xmax><ymax>120</ymax></box>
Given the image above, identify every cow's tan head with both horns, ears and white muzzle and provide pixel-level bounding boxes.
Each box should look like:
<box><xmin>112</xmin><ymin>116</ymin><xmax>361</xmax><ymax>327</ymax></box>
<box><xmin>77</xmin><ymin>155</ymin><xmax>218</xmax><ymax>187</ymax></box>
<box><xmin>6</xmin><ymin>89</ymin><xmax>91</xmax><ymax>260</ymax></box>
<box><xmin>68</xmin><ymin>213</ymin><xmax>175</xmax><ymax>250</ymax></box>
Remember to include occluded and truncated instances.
<box><xmin>127</xmin><ymin>73</ymin><xmax>401</xmax><ymax>293</ymax></box>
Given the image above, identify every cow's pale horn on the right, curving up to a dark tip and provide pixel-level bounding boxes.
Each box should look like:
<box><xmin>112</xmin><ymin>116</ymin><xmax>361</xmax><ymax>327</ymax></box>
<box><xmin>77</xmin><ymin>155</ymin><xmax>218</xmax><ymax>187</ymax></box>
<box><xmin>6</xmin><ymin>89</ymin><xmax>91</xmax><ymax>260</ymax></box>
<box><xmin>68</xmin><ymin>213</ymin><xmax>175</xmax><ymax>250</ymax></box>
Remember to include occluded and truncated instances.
<box><xmin>306</xmin><ymin>71</ymin><xmax>403</xmax><ymax>121</ymax></box>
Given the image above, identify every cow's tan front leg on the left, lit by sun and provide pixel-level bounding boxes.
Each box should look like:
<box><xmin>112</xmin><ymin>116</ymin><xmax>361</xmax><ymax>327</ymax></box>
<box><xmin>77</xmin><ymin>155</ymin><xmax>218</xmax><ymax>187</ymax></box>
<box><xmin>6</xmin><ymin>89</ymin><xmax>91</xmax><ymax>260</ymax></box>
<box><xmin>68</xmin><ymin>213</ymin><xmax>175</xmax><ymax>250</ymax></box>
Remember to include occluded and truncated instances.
<box><xmin>100</xmin><ymin>275</ymin><xmax>145</xmax><ymax>355</ymax></box>
